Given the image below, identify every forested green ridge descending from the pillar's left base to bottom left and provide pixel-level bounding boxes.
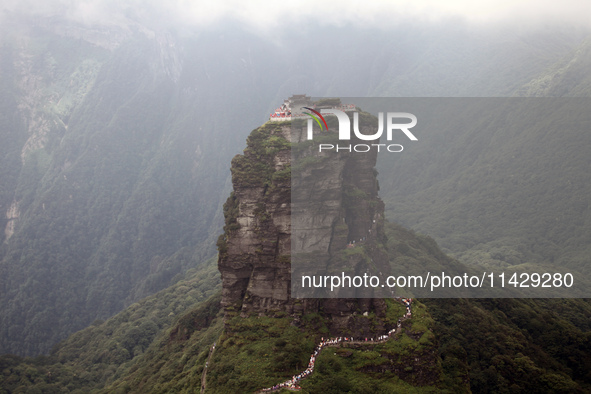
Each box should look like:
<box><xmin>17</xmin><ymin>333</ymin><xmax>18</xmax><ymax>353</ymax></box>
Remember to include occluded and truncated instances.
<box><xmin>0</xmin><ymin>259</ymin><xmax>221</xmax><ymax>393</ymax></box>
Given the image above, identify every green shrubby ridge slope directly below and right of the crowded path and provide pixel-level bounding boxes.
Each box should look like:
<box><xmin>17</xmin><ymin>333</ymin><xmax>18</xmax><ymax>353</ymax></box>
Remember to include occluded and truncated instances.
<box><xmin>301</xmin><ymin>301</ymin><xmax>446</xmax><ymax>393</ymax></box>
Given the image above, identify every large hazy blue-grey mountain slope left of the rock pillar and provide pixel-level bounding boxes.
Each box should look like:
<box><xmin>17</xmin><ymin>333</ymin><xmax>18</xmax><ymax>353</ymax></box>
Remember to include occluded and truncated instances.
<box><xmin>0</xmin><ymin>15</ymin><xmax>292</xmax><ymax>354</ymax></box>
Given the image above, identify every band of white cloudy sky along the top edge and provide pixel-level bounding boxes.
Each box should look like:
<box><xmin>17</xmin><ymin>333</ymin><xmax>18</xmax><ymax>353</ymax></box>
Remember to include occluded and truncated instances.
<box><xmin>0</xmin><ymin>0</ymin><xmax>591</xmax><ymax>31</ymax></box>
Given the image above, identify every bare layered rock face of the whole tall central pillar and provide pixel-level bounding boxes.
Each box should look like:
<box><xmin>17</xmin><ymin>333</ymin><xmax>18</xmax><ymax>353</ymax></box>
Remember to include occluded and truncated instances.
<box><xmin>218</xmin><ymin>114</ymin><xmax>394</xmax><ymax>333</ymax></box>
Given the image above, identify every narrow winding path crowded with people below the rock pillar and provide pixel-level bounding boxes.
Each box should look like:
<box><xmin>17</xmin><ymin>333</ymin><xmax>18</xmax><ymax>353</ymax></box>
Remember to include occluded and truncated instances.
<box><xmin>257</xmin><ymin>298</ymin><xmax>412</xmax><ymax>393</ymax></box>
